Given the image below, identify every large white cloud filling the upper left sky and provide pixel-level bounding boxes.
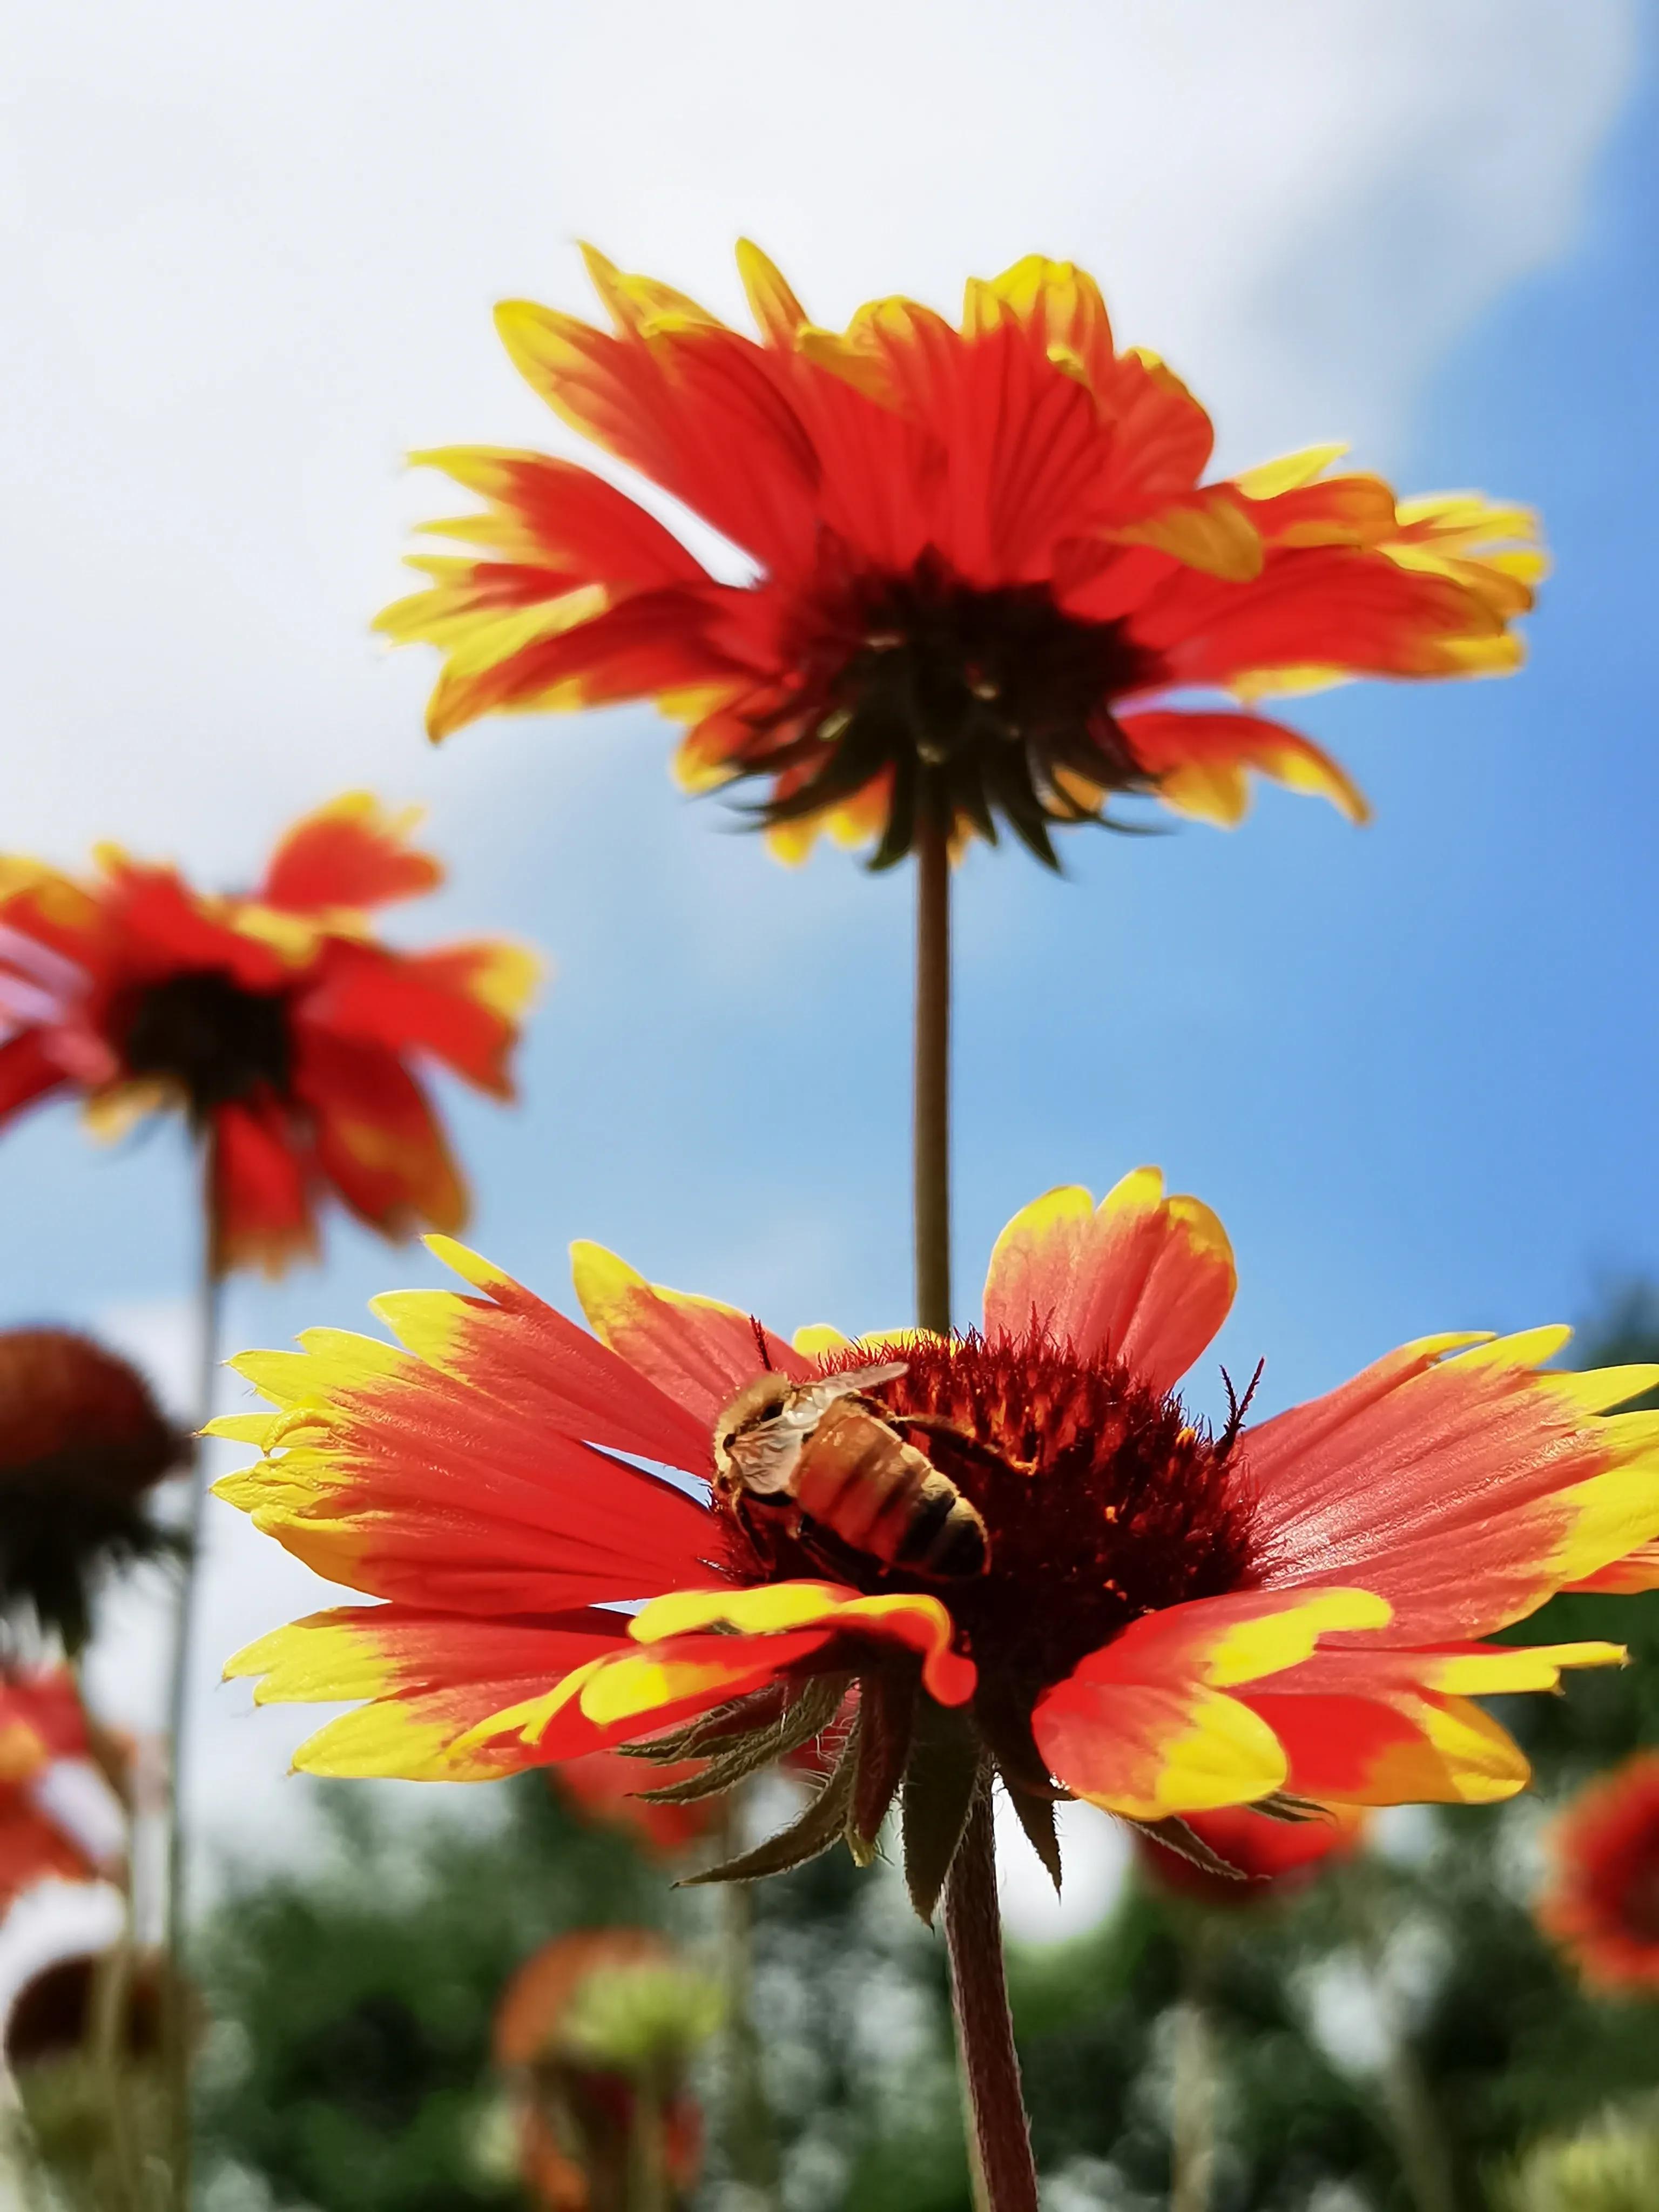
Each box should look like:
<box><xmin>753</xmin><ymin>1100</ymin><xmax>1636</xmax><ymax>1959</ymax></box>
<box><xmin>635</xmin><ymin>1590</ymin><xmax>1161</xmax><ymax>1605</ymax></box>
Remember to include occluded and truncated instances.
<box><xmin>0</xmin><ymin>0</ymin><xmax>1633</xmax><ymax>867</ymax></box>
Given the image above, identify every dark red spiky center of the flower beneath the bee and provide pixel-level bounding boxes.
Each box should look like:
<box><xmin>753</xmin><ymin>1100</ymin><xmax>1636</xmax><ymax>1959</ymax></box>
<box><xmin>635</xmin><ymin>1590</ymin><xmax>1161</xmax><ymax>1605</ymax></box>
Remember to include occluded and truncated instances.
<box><xmin>717</xmin><ymin>1336</ymin><xmax>1259</xmax><ymax>1712</ymax></box>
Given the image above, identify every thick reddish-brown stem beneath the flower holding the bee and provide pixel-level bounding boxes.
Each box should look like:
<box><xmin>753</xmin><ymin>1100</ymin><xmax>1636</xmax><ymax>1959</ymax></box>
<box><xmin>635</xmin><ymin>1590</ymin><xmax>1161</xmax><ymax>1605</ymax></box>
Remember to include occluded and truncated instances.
<box><xmin>945</xmin><ymin>1778</ymin><xmax>1037</xmax><ymax>2212</ymax></box>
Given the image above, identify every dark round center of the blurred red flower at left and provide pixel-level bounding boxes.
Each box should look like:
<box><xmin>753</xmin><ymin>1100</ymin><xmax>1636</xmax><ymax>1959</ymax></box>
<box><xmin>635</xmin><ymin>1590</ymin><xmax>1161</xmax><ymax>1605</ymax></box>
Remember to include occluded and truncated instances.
<box><xmin>117</xmin><ymin>969</ymin><xmax>292</xmax><ymax>1120</ymax></box>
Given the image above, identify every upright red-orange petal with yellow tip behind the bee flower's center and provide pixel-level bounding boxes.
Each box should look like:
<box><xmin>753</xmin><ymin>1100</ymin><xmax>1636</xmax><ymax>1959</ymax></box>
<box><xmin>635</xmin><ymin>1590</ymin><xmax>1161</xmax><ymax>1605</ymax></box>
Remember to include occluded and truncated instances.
<box><xmin>984</xmin><ymin>1168</ymin><xmax>1237</xmax><ymax>1391</ymax></box>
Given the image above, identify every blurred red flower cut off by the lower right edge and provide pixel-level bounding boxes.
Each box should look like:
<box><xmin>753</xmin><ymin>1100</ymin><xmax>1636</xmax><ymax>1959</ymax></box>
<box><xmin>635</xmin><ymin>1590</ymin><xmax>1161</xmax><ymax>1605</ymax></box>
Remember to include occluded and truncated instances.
<box><xmin>1537</xmin><ymin>1752</ymin><xmax>1659</xmax><ymax>1995</ymax></box>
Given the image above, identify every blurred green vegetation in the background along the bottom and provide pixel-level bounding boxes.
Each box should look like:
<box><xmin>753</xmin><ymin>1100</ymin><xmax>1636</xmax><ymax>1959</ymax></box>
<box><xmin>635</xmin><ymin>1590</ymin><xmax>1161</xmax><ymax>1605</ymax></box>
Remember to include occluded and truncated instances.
<box><xmin>201</xmin><ymin>1287</ymin><xmax>1659</xmax><ymax>2212</ymax></box>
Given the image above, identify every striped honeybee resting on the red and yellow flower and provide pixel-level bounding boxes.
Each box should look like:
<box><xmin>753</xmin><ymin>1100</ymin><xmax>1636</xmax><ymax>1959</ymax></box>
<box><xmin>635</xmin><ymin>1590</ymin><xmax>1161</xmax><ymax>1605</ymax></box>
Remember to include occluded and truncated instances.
<box><xmin>714</xmin><ymin>1360</ymin><xmax>991</xmax><ymax>1582</ymax></box>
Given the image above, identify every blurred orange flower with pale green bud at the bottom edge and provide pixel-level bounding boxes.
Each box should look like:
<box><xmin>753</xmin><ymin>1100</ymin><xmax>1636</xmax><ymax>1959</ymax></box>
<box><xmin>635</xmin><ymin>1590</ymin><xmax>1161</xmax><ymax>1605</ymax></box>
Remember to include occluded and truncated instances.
<box><xmin>496</xmin><ymin>1929</ymin><xmax>721</xmax><ymax>2212</ymax></box>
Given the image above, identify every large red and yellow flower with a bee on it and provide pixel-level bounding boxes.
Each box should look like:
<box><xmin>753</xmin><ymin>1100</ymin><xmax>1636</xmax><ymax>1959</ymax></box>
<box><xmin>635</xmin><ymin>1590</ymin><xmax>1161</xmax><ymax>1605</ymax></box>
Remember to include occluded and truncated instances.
<box><xmin>214</xmin><ymin>1168</ymin><xmax>1659</xmax><ymax>1909</ymax></box>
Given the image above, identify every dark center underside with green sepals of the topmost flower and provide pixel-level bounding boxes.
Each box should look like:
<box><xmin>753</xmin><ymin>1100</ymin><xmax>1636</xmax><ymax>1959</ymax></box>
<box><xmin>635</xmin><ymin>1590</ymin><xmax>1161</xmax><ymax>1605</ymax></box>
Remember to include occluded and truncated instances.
<box><xmin>745</xmin><ymin>539</ymin><xmax>1157</xmax><ymax>865</ymax></box>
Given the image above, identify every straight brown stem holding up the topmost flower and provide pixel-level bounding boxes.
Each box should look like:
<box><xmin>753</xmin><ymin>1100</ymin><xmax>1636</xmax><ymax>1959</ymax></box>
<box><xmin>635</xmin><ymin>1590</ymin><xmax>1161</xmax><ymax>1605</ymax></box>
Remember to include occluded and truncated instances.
<box><xmin>916</xmin><ymin>790</ymin><xmax>951</xmax><ymax>1334</ymax></box>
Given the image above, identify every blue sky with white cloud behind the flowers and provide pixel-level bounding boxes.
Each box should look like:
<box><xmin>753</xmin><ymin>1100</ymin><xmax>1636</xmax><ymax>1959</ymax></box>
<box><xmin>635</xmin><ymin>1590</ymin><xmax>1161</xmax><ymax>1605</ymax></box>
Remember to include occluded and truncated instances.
<box><xmin>0</xmin><ymin>0</ymin><xmax>1659</xmax><ymax>1920</ymax></box>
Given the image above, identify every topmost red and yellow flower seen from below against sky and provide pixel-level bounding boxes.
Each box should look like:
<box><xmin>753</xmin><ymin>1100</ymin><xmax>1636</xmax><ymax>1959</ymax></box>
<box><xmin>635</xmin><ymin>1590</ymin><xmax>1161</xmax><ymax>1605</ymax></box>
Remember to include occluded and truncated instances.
<box><xmin>381</xmin><ymin>244</ymin><xmax>1544</xmax><ymax>862</ymax></box>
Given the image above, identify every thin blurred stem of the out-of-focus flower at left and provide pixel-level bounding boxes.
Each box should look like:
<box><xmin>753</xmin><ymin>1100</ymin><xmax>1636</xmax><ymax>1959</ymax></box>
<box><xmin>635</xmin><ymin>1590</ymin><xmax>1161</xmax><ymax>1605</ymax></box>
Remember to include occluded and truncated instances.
<box><xmin>161</xmin><ymin>1137</ymin><xmax>224</xmax><ymax>2212</ymax></box>
